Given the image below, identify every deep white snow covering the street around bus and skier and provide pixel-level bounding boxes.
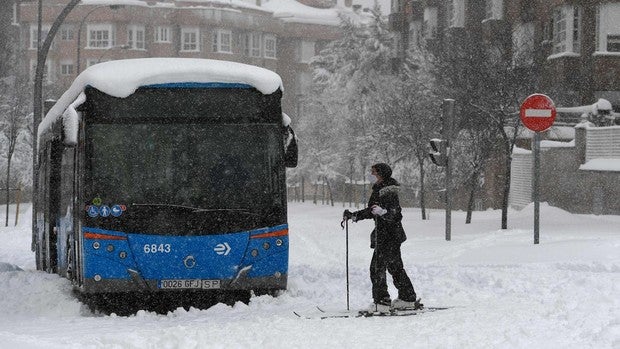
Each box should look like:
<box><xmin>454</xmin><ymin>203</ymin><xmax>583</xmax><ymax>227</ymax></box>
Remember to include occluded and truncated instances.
<box><xmin>0</xmin><ymin>203</ymin><xmax>620</xmax><ymax>348</ymax></box>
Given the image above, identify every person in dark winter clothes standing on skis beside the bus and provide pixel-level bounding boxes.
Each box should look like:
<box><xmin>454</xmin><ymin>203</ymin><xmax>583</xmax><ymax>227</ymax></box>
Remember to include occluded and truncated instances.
<box><xmin>343</xmin><ymin>163</ymin><xmax>423</xmax><ymax>313</ymax></box>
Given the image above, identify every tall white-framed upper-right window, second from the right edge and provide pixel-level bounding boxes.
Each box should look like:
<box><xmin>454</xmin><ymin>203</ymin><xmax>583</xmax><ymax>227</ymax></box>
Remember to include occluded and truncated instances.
<box><xmin>551</xmin><ymin>6</ymin><xmax>581</xmax><ymax>54</ymax></box>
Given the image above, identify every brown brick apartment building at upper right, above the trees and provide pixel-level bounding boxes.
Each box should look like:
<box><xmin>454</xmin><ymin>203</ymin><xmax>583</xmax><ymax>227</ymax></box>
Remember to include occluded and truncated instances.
<box><xmin>390</xmin><ymin>0</ymin><xmax>620</xmax><ymax>112</ymax></box>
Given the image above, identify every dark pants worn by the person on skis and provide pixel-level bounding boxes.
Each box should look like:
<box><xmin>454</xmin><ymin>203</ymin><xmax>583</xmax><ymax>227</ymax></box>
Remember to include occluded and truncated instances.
<box><xmin>370</xmin><ymin>243</ymin><xmax>416</xmax><ymax>303</ymax></box>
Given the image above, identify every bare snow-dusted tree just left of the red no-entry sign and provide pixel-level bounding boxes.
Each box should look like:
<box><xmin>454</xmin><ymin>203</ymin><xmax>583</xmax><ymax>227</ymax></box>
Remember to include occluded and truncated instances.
<box><xmin>436</xmin><ymin>29</ymin><xmax>537</xmax><ymax>229</ymax></box>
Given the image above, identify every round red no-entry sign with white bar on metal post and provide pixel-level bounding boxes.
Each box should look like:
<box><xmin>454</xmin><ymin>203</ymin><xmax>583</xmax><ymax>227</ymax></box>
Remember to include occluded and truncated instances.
<box><xmin>519</xmin><ymin>93</ymin><xmax>556</xmax><ymax>245</ymax></box>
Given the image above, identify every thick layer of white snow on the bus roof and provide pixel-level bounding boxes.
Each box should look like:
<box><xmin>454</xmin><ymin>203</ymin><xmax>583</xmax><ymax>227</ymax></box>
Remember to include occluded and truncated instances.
<box><xmin>38</xmin><ymin>58</ymin><xmax>282</xmax><ymax>137</ymax></box>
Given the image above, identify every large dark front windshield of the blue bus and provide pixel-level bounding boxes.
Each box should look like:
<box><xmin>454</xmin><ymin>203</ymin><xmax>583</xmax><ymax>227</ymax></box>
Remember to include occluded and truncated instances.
<box><xmin>86</xmin><ymin>123</ymin><xmax>285</xmax><ymax>233</ymax></box>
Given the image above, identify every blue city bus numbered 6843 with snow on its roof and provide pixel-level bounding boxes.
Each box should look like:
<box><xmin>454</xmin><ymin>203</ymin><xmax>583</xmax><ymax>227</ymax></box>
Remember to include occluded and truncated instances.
<box><xmin>32</xmin><ymin>58</ymin><xmax>297</xmax><ymax>310</ymax></box>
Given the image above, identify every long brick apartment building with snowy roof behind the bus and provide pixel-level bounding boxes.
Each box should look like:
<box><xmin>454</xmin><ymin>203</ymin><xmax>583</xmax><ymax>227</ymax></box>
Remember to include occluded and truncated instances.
<box><xmin>16</xmin><ymin>0</ymin><xmax>364</xmax><ymax>117</ymax></box>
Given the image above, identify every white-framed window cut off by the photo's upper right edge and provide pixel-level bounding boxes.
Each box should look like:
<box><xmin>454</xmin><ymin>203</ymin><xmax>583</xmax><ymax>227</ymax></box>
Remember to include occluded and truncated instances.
<box><xmin>596</xmin><ymin>2</ymin><xmax>620</xmax><ymax>53</ymax></box>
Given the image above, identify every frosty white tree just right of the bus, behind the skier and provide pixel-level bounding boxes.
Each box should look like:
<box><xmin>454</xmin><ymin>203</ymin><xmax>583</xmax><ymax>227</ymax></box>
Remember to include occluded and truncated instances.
<box><xmin>299</xmin><ymin>12</ymin><xmax>392</xmax><ymax>188</ymax></box>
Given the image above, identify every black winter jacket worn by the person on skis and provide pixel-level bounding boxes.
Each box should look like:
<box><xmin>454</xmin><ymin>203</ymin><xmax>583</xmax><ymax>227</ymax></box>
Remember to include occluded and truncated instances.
<box><xmin>353</xmin><ymin>178</ymin><xmax>407</xmax><ymax>248</ymax></box>
